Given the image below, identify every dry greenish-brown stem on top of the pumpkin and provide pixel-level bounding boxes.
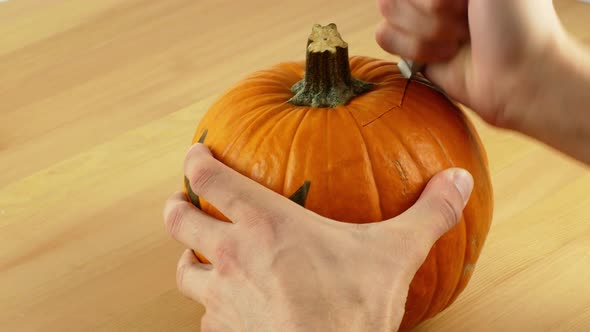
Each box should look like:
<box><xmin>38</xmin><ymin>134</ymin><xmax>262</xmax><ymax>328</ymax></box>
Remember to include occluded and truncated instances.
<box><xmin>289</xmin><ymin>23</ymin><xmax>374</xmax><ymax>107</ymax></box>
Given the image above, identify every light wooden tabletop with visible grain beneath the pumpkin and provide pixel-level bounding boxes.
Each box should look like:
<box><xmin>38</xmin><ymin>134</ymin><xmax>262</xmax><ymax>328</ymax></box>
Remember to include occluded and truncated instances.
<box><xmin>0</xmin><ymin>0</ymin><xmax>590</xmax><ymax>332</ymax></box>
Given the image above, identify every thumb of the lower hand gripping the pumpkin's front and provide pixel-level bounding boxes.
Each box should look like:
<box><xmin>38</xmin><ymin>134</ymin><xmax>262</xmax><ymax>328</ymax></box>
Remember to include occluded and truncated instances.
<box><xmin>395</xmin><ymin>168</ymin><xmax>473</xmax><ymax>246</ymax></box>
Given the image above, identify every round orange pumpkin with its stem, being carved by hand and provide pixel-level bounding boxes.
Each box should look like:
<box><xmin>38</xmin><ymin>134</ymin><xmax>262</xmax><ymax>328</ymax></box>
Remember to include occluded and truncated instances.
<box><xmin>185</xmin><ymin>24</ymin><xmax>493</xmax><ymax>330</ymax></box>
